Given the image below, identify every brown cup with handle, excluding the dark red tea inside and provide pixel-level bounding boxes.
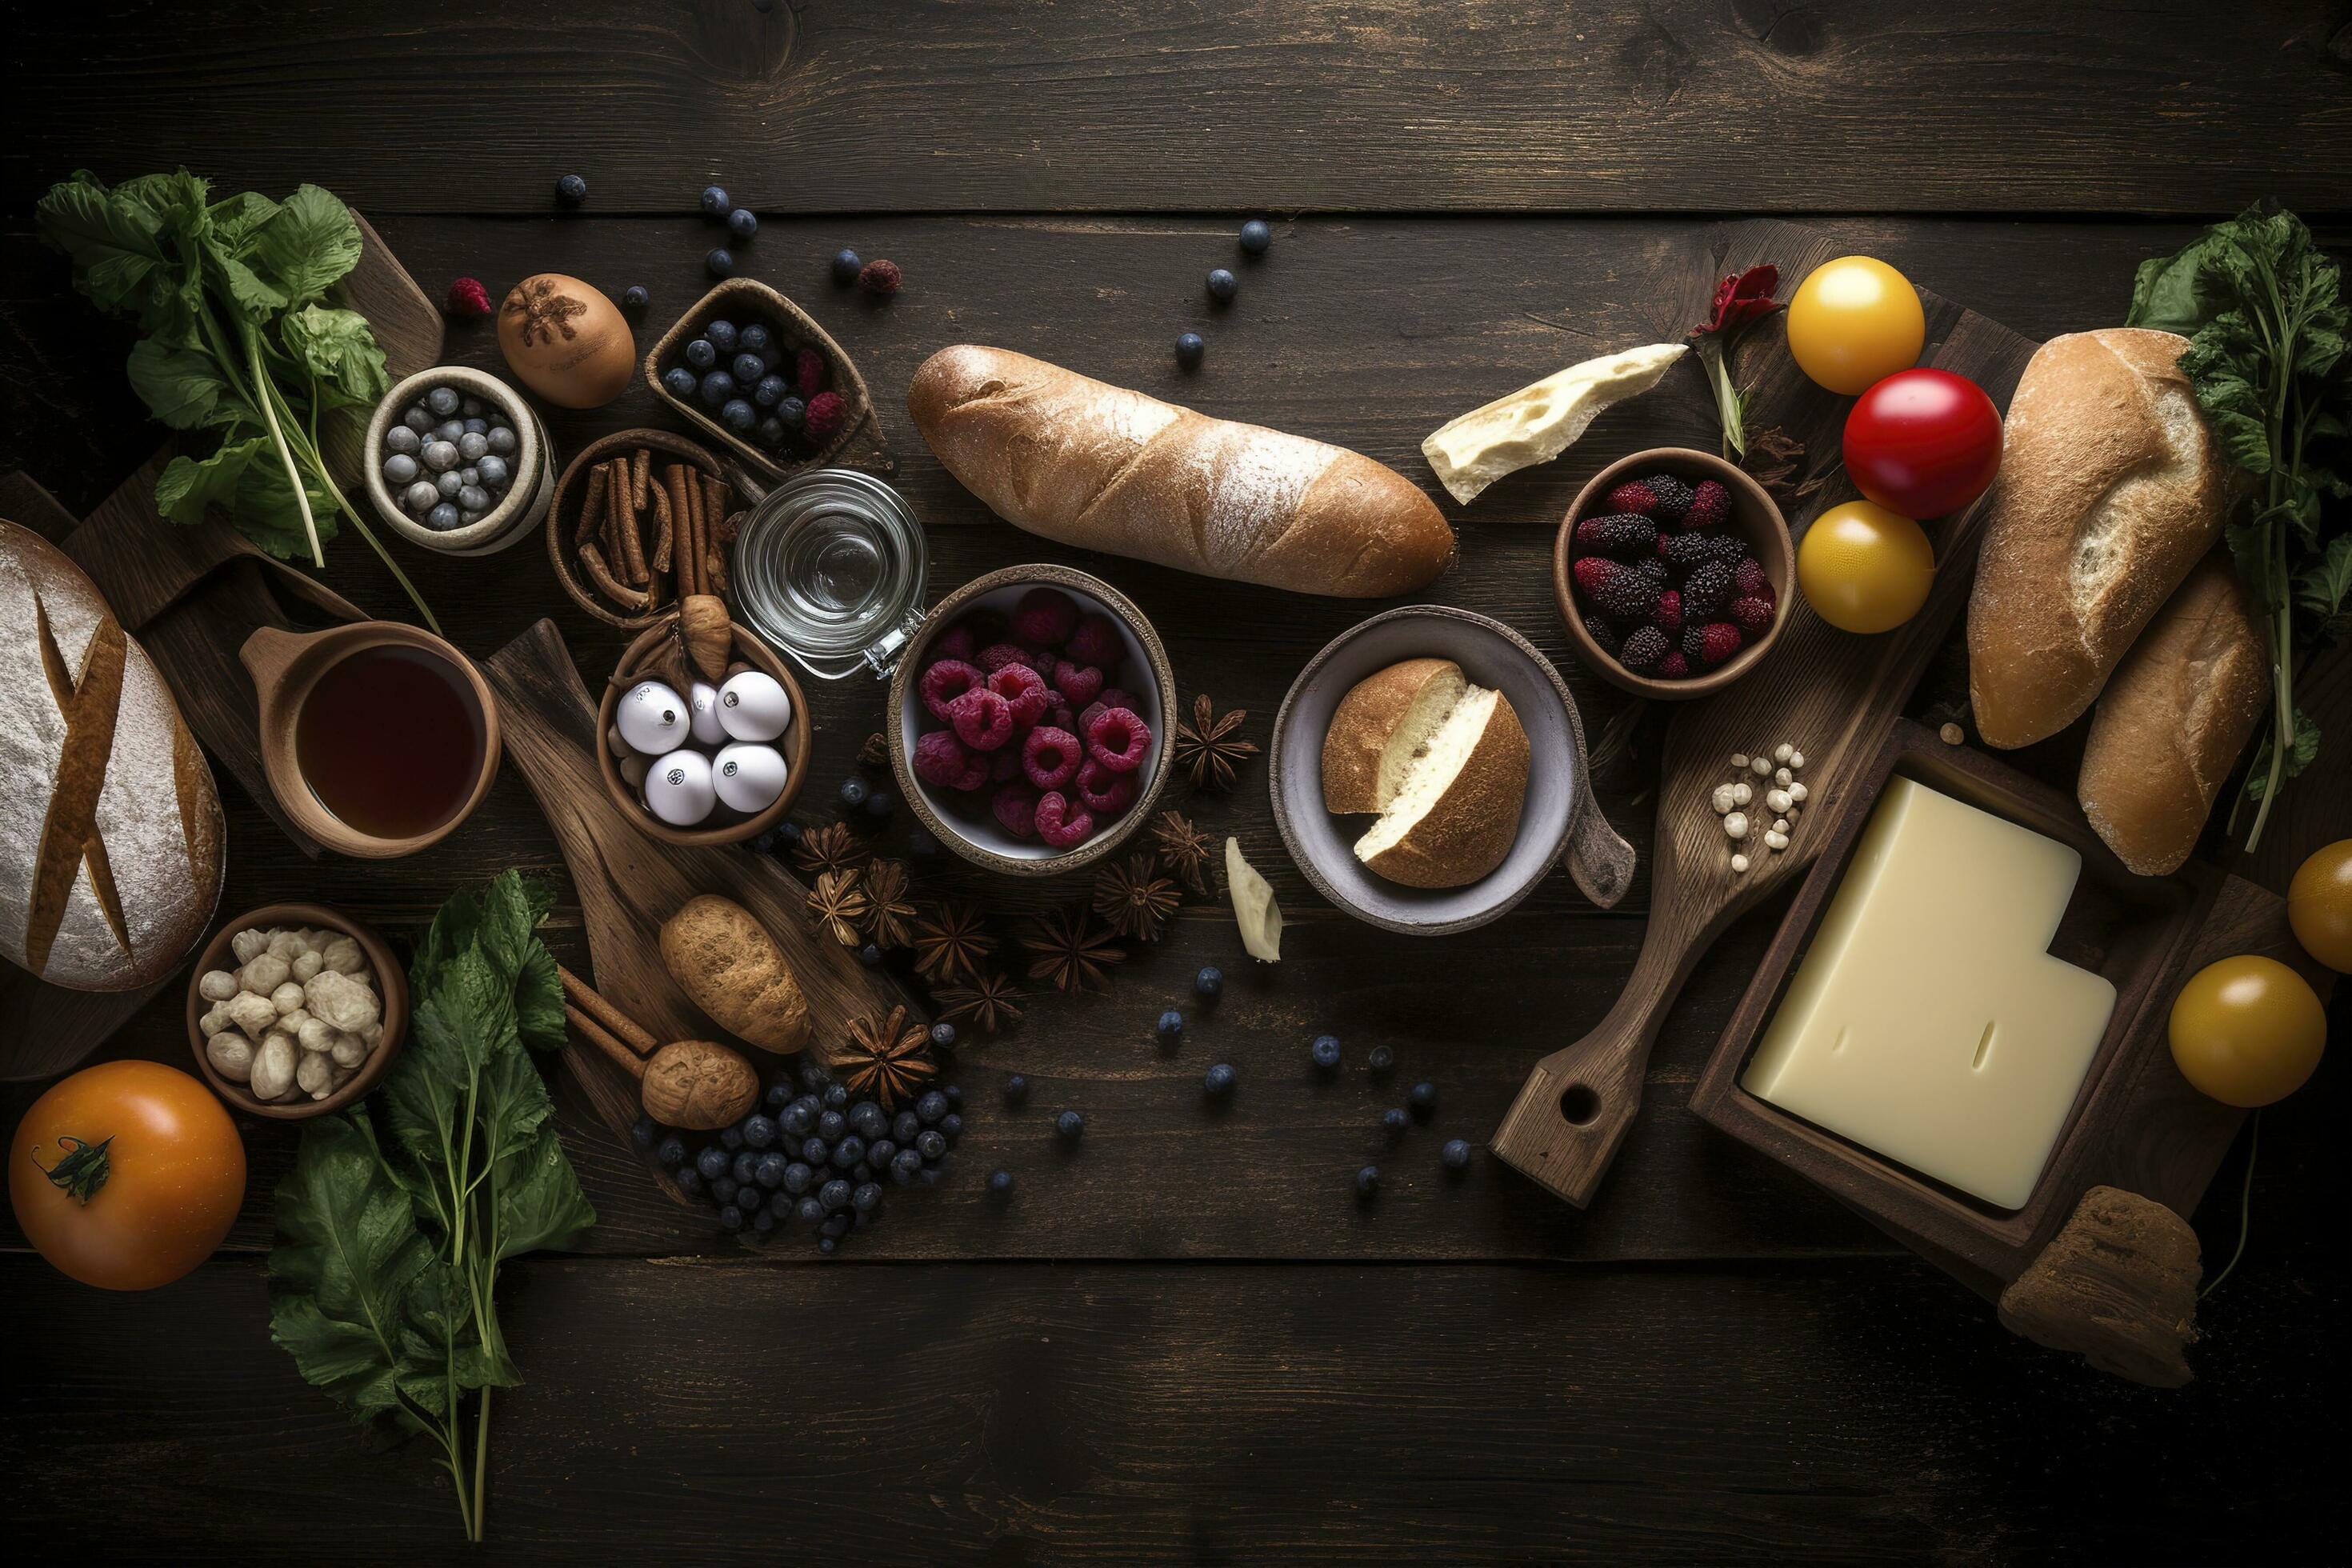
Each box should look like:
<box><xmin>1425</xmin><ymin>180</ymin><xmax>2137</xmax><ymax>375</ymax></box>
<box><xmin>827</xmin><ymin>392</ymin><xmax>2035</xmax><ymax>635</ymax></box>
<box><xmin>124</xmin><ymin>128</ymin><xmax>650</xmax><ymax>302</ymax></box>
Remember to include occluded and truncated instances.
<box><xmin>238</xmin><ymin>621</ymin><xmax>501</xmax><ymax>861</ymax></box>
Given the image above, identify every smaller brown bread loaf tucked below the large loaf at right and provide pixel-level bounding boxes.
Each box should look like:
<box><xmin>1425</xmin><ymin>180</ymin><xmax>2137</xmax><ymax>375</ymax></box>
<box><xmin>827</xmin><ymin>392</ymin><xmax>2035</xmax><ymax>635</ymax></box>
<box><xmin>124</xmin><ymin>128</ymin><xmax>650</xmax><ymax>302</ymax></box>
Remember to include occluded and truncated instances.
<box><xmin>2074</xmin><ymin>550</ymin><xmax>2270</xmax><ymax>877</ymax></box>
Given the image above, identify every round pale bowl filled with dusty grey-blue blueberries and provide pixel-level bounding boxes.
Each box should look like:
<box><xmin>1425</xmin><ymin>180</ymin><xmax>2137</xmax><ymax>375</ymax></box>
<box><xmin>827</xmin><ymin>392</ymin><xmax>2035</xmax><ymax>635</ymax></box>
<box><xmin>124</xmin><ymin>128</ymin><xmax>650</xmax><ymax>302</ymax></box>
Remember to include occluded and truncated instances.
<box><xmin>365</xmin><ymin>364</ymin><xmax>555</xmax><ymax>554</ymax></box>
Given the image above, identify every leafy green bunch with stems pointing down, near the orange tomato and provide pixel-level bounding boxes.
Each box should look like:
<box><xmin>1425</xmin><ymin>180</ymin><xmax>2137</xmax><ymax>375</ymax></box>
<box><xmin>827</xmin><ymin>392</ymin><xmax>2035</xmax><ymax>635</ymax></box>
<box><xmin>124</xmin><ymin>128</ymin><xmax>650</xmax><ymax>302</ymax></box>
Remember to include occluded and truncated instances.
<box><xmin>270</xmin><ymin>872</ymin><xmax>595</xmax><ymax>1540</ymax></box>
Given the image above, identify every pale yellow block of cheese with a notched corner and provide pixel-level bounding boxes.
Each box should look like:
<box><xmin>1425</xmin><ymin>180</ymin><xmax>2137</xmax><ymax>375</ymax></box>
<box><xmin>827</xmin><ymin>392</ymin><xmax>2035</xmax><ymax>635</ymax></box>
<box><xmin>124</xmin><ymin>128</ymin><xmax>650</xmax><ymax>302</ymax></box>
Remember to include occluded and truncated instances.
<box><xmin>1741</xmin><ymin>778</ymin><xmax>2114</xmax><ymax>1208</ymax></box>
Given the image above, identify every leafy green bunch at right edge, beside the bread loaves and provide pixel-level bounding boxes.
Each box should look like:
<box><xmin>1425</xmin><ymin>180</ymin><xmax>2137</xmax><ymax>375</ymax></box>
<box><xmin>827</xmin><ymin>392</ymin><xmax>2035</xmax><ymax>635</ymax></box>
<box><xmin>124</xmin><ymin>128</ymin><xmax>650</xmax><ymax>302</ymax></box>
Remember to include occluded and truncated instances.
<box><xmin>2124</xmin><ymin>205</ymin><xmax>2352</xmax><ymax>851</ymax></box>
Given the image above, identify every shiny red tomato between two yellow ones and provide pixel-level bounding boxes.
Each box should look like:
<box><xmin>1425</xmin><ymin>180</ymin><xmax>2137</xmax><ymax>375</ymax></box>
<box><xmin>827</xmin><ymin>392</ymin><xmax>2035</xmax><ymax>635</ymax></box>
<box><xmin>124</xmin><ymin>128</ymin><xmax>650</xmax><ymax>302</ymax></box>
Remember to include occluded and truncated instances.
<box><xmin>1846</xmin><ymin>369</ymin><xmax>2002</xmax><ymax>517</ymax></box>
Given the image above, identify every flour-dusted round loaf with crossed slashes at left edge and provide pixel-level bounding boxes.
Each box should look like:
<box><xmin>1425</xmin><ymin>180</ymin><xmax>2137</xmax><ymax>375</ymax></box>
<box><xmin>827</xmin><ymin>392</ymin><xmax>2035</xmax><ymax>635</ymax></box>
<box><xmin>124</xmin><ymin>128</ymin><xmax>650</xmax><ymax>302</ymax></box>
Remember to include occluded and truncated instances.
<box><xmin>0</xmin><ymin>522</ymin><xmax>226</xmax><ymax>992</ymax></box>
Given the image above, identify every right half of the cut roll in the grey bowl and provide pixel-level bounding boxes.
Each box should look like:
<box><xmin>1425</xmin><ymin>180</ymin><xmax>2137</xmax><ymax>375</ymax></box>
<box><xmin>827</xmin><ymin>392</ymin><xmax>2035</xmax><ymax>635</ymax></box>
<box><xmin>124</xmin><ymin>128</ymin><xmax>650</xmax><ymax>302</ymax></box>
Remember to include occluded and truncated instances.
<box><xmin>1354</xmin><ymin>686</ymin><xmax>1529</xmax><ymax>889</ymax></box>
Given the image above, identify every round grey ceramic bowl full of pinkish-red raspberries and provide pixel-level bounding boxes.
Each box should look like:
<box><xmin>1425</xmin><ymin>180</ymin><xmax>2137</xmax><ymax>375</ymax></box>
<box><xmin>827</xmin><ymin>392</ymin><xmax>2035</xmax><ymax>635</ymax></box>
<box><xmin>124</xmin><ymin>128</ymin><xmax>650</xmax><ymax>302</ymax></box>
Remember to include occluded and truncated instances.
<box><xmin>886</xmin><ymin>564</ymin><xmax>1176</xmax><ymax>877</ymax></box>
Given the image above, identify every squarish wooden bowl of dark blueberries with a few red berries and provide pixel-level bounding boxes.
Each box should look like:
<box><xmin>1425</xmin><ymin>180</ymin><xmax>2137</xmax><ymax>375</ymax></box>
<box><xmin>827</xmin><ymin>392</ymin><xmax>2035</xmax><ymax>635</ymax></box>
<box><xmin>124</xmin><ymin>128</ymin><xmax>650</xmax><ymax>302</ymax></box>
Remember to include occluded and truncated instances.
<box><xmin>645</xmin><ymin>278</ymin><xmax>896</xmax><ymax>479</ymax></box>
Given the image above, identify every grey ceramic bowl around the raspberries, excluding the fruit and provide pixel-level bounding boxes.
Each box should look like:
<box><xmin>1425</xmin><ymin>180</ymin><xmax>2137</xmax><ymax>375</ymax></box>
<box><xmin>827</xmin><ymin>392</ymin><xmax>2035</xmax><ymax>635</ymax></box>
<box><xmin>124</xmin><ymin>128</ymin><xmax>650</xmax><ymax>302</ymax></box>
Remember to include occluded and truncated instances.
<box><xmin>884</xmin><ymin>564</ymin><xmax>1176</xmax><ymax>877</ymax></box>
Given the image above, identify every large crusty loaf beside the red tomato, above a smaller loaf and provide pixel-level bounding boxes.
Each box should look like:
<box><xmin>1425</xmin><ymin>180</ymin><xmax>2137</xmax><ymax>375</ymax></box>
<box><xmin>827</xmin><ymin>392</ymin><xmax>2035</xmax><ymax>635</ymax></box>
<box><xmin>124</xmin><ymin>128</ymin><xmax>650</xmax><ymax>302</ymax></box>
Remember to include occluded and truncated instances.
<box><xmin>1969</xmin><ymin>326</ymin><xmax>2227</xmax><ymax>747</ymax></box>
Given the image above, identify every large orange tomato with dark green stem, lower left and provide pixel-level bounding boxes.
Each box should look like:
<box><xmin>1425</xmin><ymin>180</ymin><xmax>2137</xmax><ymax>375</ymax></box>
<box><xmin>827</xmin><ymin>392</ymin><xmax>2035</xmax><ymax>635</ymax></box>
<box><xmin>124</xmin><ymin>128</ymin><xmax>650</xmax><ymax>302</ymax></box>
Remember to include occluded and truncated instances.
<box><xmin>7</xmin><ymin>1062</ymin><xmax>245</xmax><ymax>1290</ymax></box>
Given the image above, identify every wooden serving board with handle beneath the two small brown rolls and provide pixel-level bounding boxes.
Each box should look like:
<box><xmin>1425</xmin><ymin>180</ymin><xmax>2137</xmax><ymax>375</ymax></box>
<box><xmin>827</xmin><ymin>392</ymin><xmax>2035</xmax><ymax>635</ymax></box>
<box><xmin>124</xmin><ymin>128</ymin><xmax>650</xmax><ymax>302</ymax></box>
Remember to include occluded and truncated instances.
<box><xmin>482</xmin><ymin>621</ymin><xmax>915</xmax><ymax>1204</ymax></box>
